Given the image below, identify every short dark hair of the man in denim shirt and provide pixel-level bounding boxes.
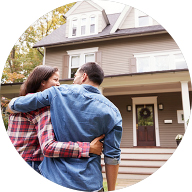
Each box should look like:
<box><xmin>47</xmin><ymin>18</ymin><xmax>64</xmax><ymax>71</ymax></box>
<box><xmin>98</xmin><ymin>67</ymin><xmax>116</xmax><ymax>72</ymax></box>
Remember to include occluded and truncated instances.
<box><xmin>79</xmin><ymin>62</ymin><xmax>104</xmax><ymax>85</ymax></box>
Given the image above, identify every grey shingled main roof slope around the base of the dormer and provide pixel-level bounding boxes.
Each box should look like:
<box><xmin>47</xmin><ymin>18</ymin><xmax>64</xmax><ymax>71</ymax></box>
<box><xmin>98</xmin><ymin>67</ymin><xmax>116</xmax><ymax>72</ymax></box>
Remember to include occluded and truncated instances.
<box><xmin>33</xmin><ymin>13</ymin><xmax>166</xmax><ymax>48</ymax></box>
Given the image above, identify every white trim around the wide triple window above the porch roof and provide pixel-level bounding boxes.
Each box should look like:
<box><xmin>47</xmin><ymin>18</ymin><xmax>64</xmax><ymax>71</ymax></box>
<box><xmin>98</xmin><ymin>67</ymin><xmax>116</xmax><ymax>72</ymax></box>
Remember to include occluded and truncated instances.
<box><xmin>133</xmin><ymin>49</ymin><xmax>186</xmax><ymax>71</ymax></box>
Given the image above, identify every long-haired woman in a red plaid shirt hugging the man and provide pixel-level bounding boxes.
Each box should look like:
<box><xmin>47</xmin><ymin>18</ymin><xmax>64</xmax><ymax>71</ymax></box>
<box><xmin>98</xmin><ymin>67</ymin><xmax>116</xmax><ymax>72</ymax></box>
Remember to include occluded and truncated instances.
<box><xmin>7</xmin><ymin>65</ymin><xmax>104</xmax><ymax>172</ymax></box>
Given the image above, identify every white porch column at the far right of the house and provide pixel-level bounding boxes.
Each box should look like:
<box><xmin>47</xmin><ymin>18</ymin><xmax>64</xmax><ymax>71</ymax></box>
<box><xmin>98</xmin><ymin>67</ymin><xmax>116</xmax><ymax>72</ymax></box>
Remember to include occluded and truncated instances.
<box><xmin>181</xmin><ymin>81</ymin><xmax>190</xmax><ymax>131</ymax></box>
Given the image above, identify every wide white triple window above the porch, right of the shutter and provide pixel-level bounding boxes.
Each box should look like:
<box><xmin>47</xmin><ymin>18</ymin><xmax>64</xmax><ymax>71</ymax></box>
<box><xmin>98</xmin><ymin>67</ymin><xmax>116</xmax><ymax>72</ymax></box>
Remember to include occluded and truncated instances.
<box><xmin>134</xmin><ymin>51</ymin><xmax>187</xmax><ymax>72</ymax></box>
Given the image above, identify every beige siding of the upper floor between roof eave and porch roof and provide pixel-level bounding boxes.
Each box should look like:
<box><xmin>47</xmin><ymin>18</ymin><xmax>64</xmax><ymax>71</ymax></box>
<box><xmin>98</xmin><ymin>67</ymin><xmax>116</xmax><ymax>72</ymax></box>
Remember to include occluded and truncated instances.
<box><xmin>45</xmin><ymin>34</ymin><xmax>178</xmax><ymax>75</ymax></box>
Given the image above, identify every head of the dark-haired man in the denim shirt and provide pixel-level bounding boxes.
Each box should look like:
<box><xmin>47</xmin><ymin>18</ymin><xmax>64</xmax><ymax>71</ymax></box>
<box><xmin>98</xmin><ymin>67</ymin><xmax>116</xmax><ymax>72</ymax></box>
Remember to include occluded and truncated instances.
<box><xmin>73</xmin><ymin>62</ymin><xmax>104</xmax><ymax>86</ymax></box>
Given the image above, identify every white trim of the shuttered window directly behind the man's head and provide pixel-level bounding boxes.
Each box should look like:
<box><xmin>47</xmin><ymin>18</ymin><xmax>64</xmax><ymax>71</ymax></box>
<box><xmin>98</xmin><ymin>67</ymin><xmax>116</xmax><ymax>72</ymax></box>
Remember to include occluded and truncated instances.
<box><xmin>67</xmin><ymin>47</ymin><xmax>99</xmax><ymax>78</ymax></box>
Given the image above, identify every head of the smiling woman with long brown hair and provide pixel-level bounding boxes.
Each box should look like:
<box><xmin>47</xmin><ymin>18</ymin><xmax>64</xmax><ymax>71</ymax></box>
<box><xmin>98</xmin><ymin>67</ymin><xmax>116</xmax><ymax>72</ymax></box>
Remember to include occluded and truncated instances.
<box><xmin>20</xmin><ymin>65</ymin><xmax>60</xmax><ymax>96</ymax></box>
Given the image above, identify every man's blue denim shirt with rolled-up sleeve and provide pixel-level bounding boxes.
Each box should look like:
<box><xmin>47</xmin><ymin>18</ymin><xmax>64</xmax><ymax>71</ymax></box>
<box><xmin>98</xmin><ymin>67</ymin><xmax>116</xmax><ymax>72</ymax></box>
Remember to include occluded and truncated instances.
<box><xmin>10</xmin><ymin>85</ymin><xmax>122</xmax><ymax>191</ymax></box>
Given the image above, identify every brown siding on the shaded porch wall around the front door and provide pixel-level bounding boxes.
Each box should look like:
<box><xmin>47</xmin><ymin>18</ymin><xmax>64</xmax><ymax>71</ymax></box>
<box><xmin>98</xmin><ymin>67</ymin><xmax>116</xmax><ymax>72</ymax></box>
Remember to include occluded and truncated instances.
<box><xmin>107</xmin><ymin>92</ymin><xmax>184</xmax><ymax>147</ymax></box>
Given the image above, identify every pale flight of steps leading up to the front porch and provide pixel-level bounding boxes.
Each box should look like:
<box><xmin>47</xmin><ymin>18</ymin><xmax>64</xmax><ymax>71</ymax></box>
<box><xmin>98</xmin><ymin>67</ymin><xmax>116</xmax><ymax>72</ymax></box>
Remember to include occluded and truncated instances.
<box><xmin>101</xmin><ymin>148</ymin><xmax>175</xmax><ymax>180</ymax></box>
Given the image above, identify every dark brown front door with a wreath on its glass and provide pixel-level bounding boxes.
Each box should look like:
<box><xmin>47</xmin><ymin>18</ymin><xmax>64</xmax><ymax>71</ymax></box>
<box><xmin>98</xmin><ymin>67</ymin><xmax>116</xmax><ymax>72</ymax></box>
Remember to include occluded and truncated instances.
<box><xmin>136</xmin><ymin>105</ymin><xmax>155</xmax><ymax>146</ymax></box>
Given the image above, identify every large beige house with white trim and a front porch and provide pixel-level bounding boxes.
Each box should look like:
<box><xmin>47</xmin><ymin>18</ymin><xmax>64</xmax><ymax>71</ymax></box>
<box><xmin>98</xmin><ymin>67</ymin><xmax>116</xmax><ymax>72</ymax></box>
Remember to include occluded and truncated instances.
<box><xmin>1</xmin><ymin>0</ymin><xmax>192</xmax><ymax>178</ymax></box>
